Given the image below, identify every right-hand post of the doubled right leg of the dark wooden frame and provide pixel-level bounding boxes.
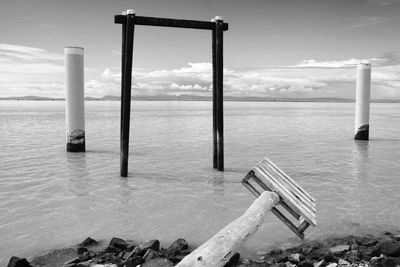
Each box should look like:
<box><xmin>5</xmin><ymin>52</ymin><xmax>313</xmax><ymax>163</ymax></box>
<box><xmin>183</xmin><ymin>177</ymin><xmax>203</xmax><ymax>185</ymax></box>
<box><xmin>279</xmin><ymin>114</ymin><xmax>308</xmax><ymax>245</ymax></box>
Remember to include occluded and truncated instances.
<box><xmin>215</xmin><ymin>16</ymin><xmax>224</xmax><ymax>171</ymax></box>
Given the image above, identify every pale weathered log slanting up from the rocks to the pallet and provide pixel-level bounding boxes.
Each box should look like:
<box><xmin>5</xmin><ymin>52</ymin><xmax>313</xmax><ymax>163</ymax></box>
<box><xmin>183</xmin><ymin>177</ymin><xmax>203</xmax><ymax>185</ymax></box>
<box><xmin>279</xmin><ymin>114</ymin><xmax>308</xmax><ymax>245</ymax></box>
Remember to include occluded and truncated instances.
<box><xmin>176</xmin><ymin>191</ymin><xmax>280</xmax><ymax>267</ymax></box>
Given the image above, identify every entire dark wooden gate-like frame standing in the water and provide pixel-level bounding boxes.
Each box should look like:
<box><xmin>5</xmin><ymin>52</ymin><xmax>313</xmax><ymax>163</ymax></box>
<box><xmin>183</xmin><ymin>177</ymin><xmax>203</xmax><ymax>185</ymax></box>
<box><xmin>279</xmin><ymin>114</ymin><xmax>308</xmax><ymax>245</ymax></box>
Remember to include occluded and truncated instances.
<box><xmin>114</xmin><ymin>10</ymin><xmax>228</xmax><ymax>177</ymax></box>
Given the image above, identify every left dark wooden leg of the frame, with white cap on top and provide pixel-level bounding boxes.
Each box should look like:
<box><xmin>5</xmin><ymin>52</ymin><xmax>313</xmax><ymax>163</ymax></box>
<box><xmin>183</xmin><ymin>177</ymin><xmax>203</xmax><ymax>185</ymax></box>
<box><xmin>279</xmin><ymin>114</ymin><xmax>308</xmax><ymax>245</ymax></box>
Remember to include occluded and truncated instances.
<box><xmin>120</xmin><ymin>10</ymin><xmax>135</xmax><ymax>177</ymax></box>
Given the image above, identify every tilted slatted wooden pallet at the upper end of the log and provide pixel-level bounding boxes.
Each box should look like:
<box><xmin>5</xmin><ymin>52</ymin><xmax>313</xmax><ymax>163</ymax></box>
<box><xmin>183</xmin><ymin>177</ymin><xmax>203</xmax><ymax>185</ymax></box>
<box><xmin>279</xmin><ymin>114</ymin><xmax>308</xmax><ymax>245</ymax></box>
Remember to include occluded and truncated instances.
<box><xmin>242</xmin><ymin>158</ymin><xmax>317</xmax><ymax>239</ymax></box>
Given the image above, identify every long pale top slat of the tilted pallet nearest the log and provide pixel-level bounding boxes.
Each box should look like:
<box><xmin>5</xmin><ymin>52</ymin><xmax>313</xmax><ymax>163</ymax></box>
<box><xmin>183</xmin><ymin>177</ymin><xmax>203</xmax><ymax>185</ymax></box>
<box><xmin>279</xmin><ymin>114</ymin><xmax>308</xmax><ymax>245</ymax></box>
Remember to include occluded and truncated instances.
<box><xmin>253</xmin><ymin>167</ymin><xmax>315</xmax><ymax>224</ymax></box>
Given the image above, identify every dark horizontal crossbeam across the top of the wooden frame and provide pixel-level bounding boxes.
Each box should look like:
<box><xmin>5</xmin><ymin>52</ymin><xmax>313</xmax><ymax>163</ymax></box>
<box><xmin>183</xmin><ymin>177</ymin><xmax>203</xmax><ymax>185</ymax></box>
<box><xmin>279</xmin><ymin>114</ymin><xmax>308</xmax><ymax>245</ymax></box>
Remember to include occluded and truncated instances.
<box><xmin>114</xmin><ymin>15</ymin><xmax>228</xmax><ymax>31</ymax></box>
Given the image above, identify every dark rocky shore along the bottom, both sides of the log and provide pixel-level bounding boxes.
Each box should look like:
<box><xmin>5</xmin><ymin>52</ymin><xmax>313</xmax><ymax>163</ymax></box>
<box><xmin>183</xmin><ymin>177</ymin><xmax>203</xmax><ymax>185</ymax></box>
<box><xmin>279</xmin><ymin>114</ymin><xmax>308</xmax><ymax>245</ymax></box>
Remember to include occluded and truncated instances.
<box><xmin>7</xmin><ymin>232</ymin><xmax>400</xmax><ymax>267</ymax></box>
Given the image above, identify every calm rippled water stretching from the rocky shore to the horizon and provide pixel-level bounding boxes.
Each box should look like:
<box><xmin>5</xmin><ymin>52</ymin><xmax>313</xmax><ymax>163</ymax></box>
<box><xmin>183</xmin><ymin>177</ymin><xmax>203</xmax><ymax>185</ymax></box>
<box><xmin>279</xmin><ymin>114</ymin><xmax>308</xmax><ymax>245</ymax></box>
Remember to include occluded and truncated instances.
<box><xmin>0</xmin><ymin>101</ymin><xmax>400</xmax><ymax>265</ymax></box>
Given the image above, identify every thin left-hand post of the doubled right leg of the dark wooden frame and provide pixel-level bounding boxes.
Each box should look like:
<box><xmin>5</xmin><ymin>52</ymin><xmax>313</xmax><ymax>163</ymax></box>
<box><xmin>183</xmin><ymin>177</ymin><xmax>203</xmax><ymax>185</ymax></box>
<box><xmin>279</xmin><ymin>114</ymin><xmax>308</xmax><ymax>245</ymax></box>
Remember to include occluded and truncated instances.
<box><xmin>211</xmin><ymin>19</ymin><xmax>218</xmax><ymax>169</ymax></box>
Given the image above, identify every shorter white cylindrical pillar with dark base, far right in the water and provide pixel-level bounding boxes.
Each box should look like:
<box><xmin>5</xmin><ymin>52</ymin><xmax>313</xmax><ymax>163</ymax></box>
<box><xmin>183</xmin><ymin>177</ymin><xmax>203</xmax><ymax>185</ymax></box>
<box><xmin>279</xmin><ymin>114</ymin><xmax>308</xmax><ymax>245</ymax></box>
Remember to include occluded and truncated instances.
<box><xmin>354</xmin><ymin>62</ymin><xmax>371</xmax><ymax>140</ymax></box>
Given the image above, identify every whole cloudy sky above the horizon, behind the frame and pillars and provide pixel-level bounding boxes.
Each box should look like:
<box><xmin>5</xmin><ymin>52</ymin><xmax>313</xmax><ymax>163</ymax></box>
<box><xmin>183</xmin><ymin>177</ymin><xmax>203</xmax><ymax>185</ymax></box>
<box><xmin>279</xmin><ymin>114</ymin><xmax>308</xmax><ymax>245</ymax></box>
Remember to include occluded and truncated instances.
<box><xmin>0</xmin><ymin>0</ymin><xmax>400</xmax><ymax>99</ymax></box>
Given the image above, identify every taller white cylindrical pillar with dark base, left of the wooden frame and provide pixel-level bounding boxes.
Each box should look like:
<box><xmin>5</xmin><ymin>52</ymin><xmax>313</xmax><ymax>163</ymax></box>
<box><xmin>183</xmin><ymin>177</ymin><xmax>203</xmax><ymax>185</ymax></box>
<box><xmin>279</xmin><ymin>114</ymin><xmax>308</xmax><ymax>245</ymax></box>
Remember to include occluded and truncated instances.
<box><xmin>64</xmin><ymin>47</ymin><xmax>85</xmax><ymax>152</ymax></box>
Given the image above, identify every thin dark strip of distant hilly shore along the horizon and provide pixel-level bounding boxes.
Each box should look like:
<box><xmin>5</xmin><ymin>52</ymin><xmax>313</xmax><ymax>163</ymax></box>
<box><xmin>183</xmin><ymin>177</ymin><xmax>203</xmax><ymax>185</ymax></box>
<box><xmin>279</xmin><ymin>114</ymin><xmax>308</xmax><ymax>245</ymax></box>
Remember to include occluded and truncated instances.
<box><xmin>0</xmin><ymin>96</ymin><xmax>400</xmax><ymax>103</ymax></box>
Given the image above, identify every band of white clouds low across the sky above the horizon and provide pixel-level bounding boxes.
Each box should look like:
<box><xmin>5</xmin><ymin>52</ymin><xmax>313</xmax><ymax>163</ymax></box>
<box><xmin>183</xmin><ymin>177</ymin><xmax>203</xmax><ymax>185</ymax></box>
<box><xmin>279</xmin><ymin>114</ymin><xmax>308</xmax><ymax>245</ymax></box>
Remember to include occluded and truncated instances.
<box><xmin>0</xmin><ymin>44</ymin><xmax>400</xmax><ymax>99</ymax></box>
